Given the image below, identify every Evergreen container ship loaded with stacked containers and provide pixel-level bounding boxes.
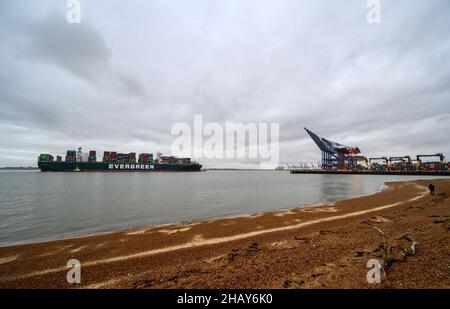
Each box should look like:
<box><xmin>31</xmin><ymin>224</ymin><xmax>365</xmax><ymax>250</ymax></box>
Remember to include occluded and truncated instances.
<box><xmin>38</xmin><ymin>148</ymin><xmax>202</xmax><ymax>172</ymax></box>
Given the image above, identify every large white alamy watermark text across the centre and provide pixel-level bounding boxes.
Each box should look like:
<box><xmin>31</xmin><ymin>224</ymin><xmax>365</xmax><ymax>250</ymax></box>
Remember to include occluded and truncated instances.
<box><xmin>170</xmin><ymin>115</ymin><xmax>280</xmax><ymax>168</ymax></box>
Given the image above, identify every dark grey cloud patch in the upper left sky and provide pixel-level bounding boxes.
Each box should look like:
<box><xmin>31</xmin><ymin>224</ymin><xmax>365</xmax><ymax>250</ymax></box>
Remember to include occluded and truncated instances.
<box><xmin>11</xmin><ymin>11</ymin><xmax>146</xmax><ymax>98</ymax></box>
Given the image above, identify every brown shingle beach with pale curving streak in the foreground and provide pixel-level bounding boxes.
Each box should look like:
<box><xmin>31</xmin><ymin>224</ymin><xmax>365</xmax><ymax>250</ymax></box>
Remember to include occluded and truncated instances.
<box><xmin>0</xmin><ymin>179</ymin><xmax>450</xmax><ymax>288</ymax></box>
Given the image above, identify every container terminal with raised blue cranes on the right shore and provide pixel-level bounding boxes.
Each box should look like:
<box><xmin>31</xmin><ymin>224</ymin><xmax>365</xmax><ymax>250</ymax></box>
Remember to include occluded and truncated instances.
<box><xmin>290</xmin><ymin>128</ymin><xmax>450</xmax><ymax>176</ymax></box>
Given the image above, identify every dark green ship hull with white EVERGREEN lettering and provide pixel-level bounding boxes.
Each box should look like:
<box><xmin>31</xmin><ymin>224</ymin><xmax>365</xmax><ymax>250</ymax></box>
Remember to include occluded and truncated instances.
<box><xmin>38</xmin><ymin>161</ymin><xmax>202</xmax><ymax>172</ymax></box>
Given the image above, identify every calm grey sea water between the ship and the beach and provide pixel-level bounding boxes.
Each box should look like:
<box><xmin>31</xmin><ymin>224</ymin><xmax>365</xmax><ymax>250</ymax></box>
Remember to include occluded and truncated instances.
<box><xmin>0</xmin><ymin>171</ymin><xmax>442</xmax><ymax>246</ymax></box>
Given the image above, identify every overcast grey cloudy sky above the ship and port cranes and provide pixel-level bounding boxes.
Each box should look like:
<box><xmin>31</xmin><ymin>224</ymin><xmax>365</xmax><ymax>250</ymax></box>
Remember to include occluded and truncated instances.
<box><xmin>0</xmin><ymin>0</ymin><xmax>450</xmax><ymax>166</ymax></box>
